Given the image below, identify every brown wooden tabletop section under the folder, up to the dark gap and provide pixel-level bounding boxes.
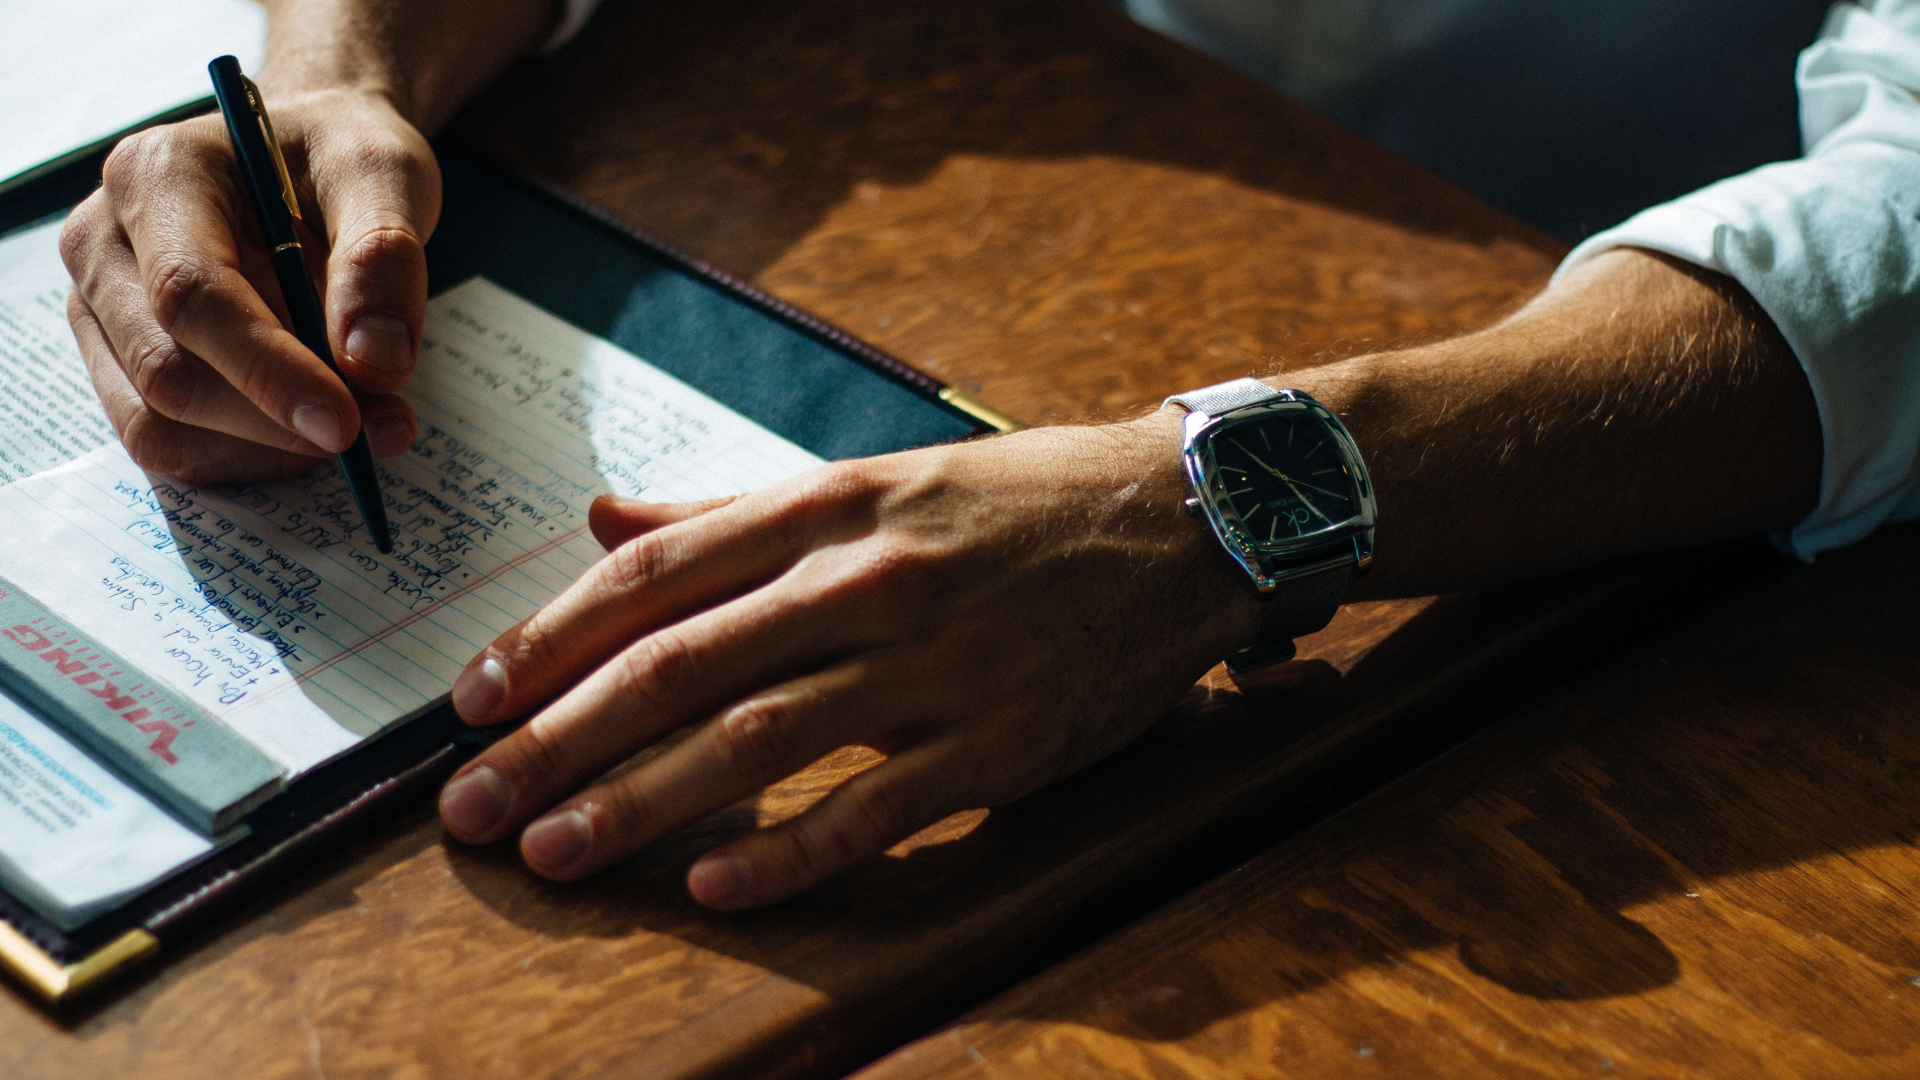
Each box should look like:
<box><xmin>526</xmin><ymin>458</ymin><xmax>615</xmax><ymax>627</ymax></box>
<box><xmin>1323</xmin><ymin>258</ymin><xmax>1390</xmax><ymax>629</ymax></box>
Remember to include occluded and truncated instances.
<box><xmin>0</xmin><ymin>0</ymin><xmax>1720</xmax><ymax>1080</ymax></box>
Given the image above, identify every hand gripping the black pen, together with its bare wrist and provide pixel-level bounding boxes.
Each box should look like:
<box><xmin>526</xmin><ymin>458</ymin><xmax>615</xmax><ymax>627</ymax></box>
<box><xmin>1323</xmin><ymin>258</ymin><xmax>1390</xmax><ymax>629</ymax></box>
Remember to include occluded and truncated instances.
<box><xmin>61</xmin><ymin>0</ymin><xmax>555</xmax><ymax>482</ymax></box>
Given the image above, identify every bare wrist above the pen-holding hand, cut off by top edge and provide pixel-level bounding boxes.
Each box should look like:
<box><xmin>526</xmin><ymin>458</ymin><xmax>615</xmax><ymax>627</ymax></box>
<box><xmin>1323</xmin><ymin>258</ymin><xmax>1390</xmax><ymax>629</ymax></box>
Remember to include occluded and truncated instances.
<box><xmin>259</xmin><ymin>0</ymin><xmax>557</xmax><ymax>135</ymax></box>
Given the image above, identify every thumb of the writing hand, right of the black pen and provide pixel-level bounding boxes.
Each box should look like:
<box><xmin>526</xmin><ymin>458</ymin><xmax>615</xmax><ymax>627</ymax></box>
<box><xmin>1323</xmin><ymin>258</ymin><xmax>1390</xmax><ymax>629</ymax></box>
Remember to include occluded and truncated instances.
<box><xmin>317</xmin><ymin>131</ymin><xmax>440</xmax><ymax>394</ymax></box>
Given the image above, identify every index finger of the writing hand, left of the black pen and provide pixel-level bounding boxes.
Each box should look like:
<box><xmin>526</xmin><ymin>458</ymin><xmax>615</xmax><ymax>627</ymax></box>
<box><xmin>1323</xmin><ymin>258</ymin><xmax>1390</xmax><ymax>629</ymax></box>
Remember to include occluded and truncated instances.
<box><xmin>104</xmin><ymin>126</ymin><xmax>361</xmax><ymax>454</ymax></box>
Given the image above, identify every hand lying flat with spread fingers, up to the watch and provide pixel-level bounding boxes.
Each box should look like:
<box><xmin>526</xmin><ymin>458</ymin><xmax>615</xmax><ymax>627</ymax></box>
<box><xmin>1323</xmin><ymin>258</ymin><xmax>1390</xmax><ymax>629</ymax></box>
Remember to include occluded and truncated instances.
<box><xmin>442</xmin><ymin>411</ymin><xmax>1256</xmax><ymax>909</ymax></box>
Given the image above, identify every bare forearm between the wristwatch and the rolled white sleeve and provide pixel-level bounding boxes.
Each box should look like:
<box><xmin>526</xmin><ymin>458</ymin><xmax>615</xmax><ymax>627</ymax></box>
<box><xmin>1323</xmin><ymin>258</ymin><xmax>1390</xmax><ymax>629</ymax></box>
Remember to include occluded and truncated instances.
<box><xmin>1288</xmin><ymin>250</ymin><xmax>1820</xmax><ymax>598</ymax></box>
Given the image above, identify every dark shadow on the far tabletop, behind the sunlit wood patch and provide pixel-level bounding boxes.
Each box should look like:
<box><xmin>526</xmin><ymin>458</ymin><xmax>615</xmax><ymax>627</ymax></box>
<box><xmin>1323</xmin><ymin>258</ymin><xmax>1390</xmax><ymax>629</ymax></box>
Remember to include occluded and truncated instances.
<box><xmin>459</xmin><ymin>0</ymin><xmax>1563</xmax><ymax>277</ymax></box>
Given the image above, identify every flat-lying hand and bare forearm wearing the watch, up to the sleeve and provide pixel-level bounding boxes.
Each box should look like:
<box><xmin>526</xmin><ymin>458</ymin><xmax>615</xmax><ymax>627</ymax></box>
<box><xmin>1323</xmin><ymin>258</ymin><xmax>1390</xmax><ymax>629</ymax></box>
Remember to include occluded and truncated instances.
<box><xmin>440</xmin><ymin>252</ymin><xmax>1820</xmax><ymax>909</ymax></box>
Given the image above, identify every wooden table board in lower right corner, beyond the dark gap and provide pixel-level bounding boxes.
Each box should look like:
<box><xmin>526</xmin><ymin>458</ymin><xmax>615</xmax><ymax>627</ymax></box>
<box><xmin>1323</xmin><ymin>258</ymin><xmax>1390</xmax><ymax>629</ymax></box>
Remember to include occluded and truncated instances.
<box><xmin>860</xmin><ymin>527</ymin><xmax>1920</xmax><ymax>1080</ymax></box>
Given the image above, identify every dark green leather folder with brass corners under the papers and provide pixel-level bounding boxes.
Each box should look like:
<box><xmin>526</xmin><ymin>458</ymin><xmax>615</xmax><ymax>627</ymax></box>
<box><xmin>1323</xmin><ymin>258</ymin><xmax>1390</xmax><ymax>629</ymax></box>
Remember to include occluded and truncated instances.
<box><xmin>0</xmin><ymin>148</ymin><xmax>1016</xmax><ymax>1003</ymax></box>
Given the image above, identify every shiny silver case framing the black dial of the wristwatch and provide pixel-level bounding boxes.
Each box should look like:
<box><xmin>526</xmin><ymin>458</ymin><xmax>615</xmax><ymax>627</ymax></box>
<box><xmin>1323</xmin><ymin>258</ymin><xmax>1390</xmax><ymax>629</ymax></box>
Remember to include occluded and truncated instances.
<box><xmin>1181</xmin><ymin>390</ymin><xmax>1377</xmax><ymax>594</ymax></box>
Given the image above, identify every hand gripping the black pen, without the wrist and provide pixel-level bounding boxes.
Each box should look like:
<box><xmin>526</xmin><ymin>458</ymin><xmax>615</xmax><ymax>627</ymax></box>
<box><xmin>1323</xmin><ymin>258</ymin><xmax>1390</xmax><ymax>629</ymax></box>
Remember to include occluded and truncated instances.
<box><xmin>60</xmin><ymin>88</ymin><xmax>440</xmax><ymax>482</ymax></box>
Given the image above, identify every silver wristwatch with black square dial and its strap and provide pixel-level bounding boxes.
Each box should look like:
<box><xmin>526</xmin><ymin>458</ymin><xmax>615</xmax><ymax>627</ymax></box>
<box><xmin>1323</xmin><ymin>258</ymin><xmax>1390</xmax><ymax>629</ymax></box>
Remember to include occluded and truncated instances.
<box><xmin>1165</xmin><ymin>379</ymin><xmax>1375</xmax><ymax>673</ymax></box>
